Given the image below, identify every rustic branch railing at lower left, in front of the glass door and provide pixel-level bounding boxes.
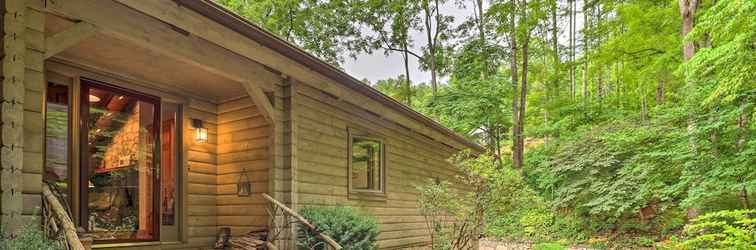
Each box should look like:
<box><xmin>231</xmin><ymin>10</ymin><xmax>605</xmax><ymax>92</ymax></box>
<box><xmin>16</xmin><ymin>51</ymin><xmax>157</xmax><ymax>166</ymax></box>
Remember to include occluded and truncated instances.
<box><xmin>42</xmin><ymin>183</ymin><xmax>91</xmax><ymax>250</ymax></box>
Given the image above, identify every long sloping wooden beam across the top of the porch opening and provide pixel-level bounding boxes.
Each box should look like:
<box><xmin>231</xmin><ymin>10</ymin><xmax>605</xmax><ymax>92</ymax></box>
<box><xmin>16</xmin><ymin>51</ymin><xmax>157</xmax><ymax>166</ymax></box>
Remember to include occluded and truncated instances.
<box><xmin>26</xmin><ymin>0</ymin><xmax>280</xmax><ymax>91</ymax></box>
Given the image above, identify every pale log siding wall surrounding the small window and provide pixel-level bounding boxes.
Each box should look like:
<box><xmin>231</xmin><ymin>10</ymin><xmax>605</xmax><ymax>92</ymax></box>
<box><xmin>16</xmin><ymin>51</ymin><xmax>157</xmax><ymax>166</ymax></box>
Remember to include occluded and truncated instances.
<box><xmin>294</xmin><ymin>81</ymin><xmax>457</xmax><ymax>249</ymax></box>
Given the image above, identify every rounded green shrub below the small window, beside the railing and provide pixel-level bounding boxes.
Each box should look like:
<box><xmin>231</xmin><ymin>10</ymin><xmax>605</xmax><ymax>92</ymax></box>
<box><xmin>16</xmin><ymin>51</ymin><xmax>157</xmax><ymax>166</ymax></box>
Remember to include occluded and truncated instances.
<box><xmin>297</xmin><ymin>206</ymin><xmax>379</xmax><ymax>250</ymax></box>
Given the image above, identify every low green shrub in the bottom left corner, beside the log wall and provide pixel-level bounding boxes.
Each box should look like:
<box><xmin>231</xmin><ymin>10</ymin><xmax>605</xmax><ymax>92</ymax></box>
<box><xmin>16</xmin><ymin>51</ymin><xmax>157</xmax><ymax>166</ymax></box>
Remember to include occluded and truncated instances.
<box><xmin>0</xmin><ymin>222</ymin><xmax>64</xmax><ymax>250</ymax></box>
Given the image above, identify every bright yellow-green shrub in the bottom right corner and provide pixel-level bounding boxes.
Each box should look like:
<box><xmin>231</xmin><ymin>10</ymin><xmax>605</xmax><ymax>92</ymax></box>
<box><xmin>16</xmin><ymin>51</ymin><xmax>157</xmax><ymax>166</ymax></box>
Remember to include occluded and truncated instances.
<box><xmin>674</xmin><ymin>210</ymin><xmax>756</xmax><ymax>249</ymax></box>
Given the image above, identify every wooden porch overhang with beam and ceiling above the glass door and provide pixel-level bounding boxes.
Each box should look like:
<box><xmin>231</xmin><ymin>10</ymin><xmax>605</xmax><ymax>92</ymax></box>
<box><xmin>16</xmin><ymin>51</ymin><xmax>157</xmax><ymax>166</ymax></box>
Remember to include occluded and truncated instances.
<box><xmin>26</xmin><ymin>0</ymin><xmax>282</xmax><ymax>106</ymax></box>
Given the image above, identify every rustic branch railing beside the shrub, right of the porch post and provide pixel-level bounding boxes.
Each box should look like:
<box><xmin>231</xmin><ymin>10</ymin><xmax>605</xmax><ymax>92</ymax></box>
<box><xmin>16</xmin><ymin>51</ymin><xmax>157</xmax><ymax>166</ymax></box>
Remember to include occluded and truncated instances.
<box><xmin>262</xmin><ymin>194</ymin><xmax>342</xmax><ymax>250</ymax></box>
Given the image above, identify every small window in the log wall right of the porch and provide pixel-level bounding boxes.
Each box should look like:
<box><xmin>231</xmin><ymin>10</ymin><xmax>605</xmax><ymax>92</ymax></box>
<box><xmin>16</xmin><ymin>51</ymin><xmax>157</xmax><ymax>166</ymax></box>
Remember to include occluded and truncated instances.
<box><xmin>349</xmin><ymin>133</ymin><xmax>385</xmax><ymax>192</ymax></box>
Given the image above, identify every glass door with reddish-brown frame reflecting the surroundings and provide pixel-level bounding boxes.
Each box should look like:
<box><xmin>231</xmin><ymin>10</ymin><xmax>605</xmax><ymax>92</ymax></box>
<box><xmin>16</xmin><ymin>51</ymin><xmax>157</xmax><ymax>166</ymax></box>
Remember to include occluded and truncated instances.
<box><xmin>81</xmin><ymin>80</ymin><xmax>160</xmax><ymax>241</ymax></box>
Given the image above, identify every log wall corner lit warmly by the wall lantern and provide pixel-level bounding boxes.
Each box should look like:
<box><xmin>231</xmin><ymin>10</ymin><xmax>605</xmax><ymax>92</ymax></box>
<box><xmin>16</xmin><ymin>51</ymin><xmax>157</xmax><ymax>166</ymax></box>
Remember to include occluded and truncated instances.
<box><xmin>182</xmin><ymin>96</ymin><xmax>270</xmax><ymax>247</ymax></box>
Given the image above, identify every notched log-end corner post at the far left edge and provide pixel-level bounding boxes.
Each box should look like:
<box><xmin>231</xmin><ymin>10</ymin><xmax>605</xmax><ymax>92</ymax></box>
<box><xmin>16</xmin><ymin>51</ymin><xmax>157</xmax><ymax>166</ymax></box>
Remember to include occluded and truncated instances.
<box><xmin>0</xmin><ymin>0</ymin><xmax>26</xmax><ymax>235</ymax></box>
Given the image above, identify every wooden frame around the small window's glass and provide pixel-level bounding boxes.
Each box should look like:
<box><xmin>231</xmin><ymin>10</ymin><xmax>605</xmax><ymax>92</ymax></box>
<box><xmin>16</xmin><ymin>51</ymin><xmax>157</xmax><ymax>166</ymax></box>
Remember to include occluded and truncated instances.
<box><xmin>347</xmin><ymin>129</ymin><xmax>387</xmax><ymax>196</ymax></box>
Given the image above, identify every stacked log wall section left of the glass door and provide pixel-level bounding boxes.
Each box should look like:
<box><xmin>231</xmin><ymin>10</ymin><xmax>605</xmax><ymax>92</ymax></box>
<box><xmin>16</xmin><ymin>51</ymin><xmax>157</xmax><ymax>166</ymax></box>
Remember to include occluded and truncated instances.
<box><xmin>0</xmin><ymin>0</ymin><xmax>45</xmax><ymax>230</ymax></box>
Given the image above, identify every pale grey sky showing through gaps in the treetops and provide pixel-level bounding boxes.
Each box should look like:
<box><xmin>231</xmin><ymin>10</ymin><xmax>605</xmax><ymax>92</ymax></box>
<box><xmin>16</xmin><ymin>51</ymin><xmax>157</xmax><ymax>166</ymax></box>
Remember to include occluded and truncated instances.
<box><xmin>342</xmin><ymin>1</ymin><xmax>583</xmax><ymax>83</ymax></box>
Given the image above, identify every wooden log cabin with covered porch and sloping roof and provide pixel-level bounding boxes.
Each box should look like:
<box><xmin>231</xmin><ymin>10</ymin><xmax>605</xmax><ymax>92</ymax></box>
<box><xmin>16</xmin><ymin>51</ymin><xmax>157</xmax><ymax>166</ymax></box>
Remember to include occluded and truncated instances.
<box><xmin>0</xmin><ymin>0</ymin><xmax>481</xmax><ymax>249</ymax></box>
